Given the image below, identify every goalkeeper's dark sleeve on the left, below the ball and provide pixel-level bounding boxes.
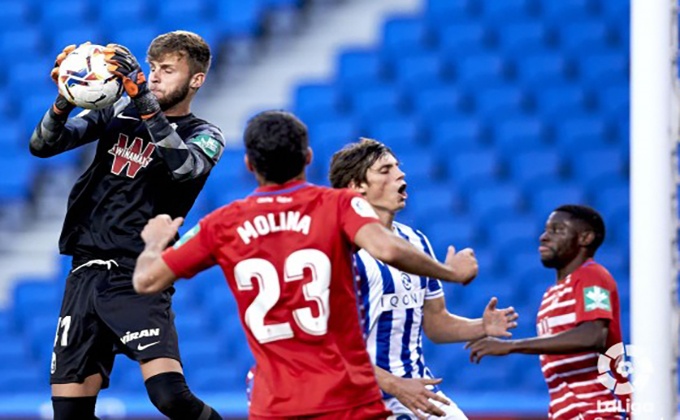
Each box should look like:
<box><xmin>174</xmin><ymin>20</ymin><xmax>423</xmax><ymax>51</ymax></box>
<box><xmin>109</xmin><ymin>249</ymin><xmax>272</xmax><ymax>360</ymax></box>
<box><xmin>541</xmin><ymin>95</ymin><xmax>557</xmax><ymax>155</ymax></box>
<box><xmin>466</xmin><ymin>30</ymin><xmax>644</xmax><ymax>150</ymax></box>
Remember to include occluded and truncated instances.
<box><xmin>29</xmin><ymin>98</ymin><xmax>129</xmax><ymax>158</ymax></box>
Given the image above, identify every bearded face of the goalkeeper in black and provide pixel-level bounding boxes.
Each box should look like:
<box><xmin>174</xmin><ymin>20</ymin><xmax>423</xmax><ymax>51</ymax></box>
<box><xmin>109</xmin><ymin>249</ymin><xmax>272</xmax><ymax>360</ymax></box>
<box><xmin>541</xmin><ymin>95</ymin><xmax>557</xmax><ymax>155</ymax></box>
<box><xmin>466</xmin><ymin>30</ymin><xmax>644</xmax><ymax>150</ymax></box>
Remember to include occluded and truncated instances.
<box><xmin>148</xmin><ymin>54</ymin><xmax>191</xmax><ymax>111</ymax></box>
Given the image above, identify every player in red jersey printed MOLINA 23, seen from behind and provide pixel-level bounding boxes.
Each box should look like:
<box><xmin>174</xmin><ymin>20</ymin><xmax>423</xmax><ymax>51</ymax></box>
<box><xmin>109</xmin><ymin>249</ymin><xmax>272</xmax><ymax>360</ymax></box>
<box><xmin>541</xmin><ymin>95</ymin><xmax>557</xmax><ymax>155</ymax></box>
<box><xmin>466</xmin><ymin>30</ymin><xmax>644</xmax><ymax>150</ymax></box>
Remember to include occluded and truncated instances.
<box><xmin>133</xmin><ymin>111</ymin><xmax>477</xmax><ymax>420</ymax></box>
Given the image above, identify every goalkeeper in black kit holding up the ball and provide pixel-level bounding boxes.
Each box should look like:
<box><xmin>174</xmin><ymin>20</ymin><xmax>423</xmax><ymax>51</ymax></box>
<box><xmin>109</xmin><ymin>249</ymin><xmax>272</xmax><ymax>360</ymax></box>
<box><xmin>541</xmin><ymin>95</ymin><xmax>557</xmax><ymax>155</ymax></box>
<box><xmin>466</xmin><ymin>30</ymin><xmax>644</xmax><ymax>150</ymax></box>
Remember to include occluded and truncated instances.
<box><xmin>30</xmin><ymin>31</ymin><xmax>224</xmax><ymax>420</ymax></box>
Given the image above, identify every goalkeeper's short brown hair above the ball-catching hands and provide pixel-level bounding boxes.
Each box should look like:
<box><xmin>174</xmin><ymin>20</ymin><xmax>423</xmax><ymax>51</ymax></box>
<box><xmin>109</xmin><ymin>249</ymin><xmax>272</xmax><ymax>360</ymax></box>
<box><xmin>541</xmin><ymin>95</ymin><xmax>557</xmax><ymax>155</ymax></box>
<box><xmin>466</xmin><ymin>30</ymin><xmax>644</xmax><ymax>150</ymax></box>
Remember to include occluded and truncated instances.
<box><xmin>146</xmin><ymin>31</ymin><xmax>211</xmax><ymax>76</ymax></box>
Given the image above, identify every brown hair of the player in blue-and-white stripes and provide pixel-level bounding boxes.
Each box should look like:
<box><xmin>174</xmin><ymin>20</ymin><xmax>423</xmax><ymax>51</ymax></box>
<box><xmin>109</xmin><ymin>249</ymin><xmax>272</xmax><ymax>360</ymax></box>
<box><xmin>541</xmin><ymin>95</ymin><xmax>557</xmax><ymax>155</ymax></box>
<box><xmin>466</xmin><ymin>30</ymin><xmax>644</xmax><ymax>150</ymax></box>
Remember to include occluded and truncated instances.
<box><xmin>328</xmin><ymin>137</ymin><xmax>394</xmax><ymax>188</ymax></box>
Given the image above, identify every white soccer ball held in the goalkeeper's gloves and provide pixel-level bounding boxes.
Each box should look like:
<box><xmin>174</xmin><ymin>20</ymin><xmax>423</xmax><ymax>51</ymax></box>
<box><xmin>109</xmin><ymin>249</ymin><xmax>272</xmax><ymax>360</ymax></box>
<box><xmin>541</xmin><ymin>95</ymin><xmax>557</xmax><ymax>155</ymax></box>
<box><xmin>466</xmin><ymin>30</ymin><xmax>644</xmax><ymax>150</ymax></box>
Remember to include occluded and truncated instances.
<box><xmin>58</xmin><ymin>44</ymin><xmax>123</xmax><ymax>109</ymax></box>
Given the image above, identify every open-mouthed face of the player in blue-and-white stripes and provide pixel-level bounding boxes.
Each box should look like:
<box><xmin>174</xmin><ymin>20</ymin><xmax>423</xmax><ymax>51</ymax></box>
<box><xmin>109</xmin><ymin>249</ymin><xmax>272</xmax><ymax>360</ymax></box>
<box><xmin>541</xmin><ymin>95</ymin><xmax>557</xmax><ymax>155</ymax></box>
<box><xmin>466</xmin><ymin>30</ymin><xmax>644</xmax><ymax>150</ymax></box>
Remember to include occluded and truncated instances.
<box><xmin>362</xmin><ymin>153</ymin><xmax>407</xmax><ymax>213</ymax></box>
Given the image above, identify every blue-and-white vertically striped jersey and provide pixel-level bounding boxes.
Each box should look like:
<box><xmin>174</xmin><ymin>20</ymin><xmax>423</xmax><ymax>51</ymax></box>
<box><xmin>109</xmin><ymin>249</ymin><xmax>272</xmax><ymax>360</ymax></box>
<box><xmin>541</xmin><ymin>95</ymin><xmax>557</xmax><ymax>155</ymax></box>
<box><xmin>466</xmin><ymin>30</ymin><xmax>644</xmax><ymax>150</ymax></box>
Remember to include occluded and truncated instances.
<box><xmin>354</xmin><ymin>222</ymin><xmax>444</xmax><ymax>397</ymax></box>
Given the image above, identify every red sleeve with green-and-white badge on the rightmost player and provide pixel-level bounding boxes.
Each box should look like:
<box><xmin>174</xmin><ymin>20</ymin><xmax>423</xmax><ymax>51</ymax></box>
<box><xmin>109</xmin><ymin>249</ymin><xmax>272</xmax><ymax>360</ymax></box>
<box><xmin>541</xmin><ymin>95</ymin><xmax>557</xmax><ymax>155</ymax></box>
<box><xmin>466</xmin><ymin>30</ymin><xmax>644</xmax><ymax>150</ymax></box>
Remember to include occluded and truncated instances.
<box><xmin>574</xmin><ymin>267</ymin><xmax>618</xmax><ymax>324</ymax></box>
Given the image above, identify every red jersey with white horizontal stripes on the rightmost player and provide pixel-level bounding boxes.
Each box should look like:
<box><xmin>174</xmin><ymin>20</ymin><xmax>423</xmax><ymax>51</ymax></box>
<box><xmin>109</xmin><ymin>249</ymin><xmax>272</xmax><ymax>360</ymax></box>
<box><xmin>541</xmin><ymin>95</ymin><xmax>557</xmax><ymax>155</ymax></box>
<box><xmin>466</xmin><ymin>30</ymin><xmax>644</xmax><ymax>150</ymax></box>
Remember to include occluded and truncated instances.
<box><xmin>537</xmin><ymin>259</ymin><xmax>622</xmax><ymax>419</ymax></box>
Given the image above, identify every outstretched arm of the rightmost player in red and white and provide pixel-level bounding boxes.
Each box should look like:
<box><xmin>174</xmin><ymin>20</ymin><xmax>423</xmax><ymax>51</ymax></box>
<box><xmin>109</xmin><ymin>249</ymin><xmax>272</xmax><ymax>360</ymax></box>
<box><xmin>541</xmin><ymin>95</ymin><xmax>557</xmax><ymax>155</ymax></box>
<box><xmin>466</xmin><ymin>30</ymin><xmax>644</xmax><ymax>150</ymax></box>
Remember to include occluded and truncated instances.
<box><xmin>465</xmin><ymin>319</ymin><xmax>609</xmax><ymax>363</ymax></box>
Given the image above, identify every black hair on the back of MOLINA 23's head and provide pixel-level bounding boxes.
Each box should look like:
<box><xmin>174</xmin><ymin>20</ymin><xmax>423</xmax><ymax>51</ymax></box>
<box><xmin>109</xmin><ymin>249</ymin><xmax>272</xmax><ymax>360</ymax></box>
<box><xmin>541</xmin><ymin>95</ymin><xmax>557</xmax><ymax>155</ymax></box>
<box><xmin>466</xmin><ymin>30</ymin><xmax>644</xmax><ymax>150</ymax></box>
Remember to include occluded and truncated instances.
<box><xmin>243</xmin><ymin>111</ymin><xmax>309</xmax><ymax>184</ymax></box>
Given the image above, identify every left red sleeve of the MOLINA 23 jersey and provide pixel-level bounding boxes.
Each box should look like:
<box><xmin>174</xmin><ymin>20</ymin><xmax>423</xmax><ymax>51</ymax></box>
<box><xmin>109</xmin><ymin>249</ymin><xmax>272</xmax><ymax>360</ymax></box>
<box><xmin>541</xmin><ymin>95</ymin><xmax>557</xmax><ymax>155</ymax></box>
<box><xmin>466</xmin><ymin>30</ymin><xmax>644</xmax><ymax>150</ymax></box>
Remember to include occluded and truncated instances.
<box><xmin>162</xmin><ymin>214</ymin><xmax>217</xmax><ymax>279</ymax></box>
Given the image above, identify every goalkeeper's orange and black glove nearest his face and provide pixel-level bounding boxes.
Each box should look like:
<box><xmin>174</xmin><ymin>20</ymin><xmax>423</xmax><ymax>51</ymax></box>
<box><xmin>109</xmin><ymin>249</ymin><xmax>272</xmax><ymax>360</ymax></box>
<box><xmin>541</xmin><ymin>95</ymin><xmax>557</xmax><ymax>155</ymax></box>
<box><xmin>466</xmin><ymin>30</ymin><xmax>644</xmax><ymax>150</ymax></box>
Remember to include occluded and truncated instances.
<box><xmin>104</xmin><ymin>44</ymin><xmax>161</xmax><ymax>120</ymax></box>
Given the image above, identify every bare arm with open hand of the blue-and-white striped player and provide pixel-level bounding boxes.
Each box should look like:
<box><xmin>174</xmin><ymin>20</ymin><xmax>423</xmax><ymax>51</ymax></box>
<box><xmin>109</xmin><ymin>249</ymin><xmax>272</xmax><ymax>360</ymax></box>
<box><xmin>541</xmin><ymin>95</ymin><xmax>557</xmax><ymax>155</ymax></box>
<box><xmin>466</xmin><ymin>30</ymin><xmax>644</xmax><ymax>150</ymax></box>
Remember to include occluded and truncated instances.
<box><xmin>423</xmin><ymin>297</ymin><xmax>519</xmax><ymax>343</ymax></box>
